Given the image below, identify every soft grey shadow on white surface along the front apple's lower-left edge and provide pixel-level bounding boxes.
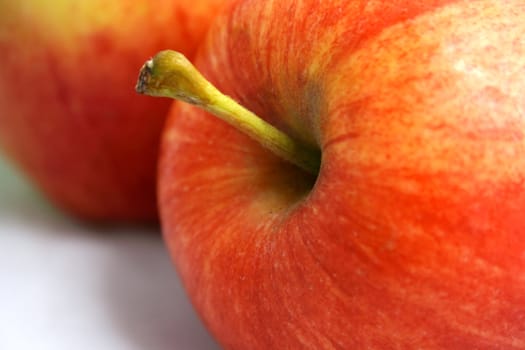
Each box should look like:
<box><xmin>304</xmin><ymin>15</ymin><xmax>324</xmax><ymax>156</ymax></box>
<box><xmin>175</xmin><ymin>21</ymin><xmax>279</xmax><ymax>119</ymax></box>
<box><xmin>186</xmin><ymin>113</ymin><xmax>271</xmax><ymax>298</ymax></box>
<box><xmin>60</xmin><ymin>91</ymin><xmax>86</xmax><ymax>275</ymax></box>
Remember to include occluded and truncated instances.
<box><xmin>102</xmin><ymin>232</ymin><xmax>218</xmax><ymax>350</ymax></box>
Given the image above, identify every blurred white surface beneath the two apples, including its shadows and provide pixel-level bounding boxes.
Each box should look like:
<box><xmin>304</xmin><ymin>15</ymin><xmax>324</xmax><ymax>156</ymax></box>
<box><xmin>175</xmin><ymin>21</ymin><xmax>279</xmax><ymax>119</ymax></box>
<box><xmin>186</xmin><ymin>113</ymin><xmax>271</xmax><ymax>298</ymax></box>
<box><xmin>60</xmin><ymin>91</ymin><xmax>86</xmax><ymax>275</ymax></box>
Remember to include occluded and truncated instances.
<box><xmin>0</xmin><ymin>156</ymin><xmax>219</xmax><ymax>350</ymax></box>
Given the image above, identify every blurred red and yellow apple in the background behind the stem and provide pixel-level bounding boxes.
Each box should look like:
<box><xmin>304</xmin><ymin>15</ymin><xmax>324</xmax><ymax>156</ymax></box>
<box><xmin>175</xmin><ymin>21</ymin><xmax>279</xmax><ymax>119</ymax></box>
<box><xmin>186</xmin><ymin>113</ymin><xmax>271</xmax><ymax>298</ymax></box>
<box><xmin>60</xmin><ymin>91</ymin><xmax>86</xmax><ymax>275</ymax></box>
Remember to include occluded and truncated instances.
<box><xmin>0</xmin><ymin>0</ymin><xmax>226</xmax><ymax>221</ymax></box>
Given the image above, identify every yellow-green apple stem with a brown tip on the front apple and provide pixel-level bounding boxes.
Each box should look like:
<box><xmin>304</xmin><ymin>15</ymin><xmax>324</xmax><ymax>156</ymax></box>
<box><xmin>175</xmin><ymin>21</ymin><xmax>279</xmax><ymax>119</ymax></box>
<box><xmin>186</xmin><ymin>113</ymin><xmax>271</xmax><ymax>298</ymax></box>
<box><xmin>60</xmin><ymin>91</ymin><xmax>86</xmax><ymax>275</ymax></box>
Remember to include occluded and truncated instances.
<box><xmin>136</xmin><ymin>50</ymin><xmax>321</xmax><ymax>175</ymax></box>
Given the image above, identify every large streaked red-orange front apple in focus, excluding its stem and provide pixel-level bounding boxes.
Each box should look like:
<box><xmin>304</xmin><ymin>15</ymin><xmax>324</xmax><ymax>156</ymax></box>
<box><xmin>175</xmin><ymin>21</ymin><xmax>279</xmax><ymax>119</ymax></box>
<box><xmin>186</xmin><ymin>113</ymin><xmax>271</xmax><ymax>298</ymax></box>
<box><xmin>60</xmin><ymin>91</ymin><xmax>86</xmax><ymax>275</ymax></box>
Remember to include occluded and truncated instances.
<box><xmin>159</xmin><ymin>0</ymin><xmax>525</xmax><ymax>350</ymax></box>
